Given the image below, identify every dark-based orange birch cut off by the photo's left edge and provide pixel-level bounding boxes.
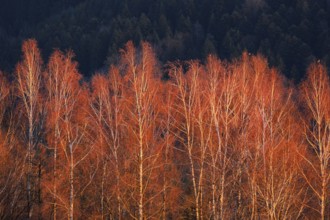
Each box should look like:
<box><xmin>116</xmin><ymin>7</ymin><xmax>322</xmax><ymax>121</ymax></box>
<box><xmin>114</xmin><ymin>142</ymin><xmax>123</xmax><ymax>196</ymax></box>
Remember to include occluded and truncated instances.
<box><xmin>0</xmin><ymin>72</ymin><xmax>26</xmax><ymax>219</ymax></box>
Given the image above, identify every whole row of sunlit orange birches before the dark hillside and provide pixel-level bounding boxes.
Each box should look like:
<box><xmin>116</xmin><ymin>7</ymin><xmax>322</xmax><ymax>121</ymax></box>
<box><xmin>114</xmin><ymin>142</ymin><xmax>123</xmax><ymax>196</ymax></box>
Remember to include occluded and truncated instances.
<box><xmin>0</xmin><ymin>39</ymin><xmax>330</xmax><ymax>220</ymax></box>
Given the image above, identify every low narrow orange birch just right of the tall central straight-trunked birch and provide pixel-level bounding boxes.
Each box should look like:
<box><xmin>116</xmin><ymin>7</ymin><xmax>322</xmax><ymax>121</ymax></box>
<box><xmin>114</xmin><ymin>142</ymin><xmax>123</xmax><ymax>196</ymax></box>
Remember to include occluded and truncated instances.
<box><xmin>158</xmin><ymin>81</ymin><xmax>182</xmax><ymax>219</ymax></box>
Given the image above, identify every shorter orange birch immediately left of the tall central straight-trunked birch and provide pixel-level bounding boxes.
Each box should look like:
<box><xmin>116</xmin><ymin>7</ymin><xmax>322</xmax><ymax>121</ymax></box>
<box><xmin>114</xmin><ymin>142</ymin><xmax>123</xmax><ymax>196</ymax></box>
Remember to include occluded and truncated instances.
<box><xmin>91</xmin><ymin>66</ymin><xmax>123</xmax><ymax>219</ymax></box>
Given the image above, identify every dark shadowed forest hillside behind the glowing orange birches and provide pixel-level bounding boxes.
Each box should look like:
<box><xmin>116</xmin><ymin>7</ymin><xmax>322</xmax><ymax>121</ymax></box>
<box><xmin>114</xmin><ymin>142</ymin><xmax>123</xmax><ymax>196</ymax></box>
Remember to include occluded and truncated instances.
<box><xmin>0</xmin><ymin>0</ymin><xmax>330</xmax><ymax>80</ymax></box>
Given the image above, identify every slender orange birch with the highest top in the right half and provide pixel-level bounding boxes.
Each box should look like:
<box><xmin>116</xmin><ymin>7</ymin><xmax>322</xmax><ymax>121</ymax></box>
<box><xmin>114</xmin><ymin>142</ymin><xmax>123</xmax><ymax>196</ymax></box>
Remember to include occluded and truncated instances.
<box><xmin>230</xmin><ymin>52</ymin><xmax>256</xmax><ymax>218</ymax></box>
